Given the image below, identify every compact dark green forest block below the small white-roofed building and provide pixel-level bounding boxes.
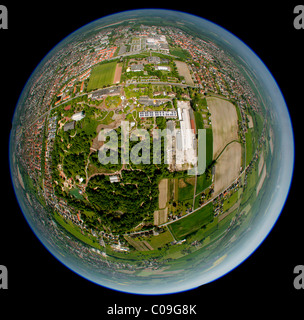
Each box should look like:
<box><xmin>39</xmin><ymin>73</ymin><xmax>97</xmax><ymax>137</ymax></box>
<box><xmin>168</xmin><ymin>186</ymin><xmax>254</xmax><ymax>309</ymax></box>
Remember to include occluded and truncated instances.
<box><xmin>86</xmin><ymin>170</ymin><xmax>158</xmax><ymax>232</ymax></box>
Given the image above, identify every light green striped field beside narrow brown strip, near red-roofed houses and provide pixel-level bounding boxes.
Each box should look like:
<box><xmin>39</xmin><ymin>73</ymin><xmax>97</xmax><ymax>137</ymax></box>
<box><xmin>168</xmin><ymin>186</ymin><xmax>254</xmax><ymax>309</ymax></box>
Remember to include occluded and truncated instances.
<box><xmin>87</xmin><ymin>61</ymin><xmax>117</xmax><ymax>91</ymax></box>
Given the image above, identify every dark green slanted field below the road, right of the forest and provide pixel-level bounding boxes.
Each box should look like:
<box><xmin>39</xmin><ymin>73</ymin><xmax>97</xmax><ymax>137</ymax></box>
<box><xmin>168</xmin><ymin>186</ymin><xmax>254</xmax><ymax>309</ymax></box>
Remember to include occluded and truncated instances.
<box><xmin>168</xmin><ymin>203</ymin><xmax>213</xmax><ymax>240</ymax></box>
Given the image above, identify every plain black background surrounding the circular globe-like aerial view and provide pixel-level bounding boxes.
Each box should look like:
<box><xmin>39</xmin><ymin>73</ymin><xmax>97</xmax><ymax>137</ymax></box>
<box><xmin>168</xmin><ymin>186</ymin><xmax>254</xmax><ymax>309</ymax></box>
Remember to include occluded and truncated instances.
<box><xmin>0</xmin><ymin>0</ymin><xmax>304</xmax><ymax>319</ymax></box>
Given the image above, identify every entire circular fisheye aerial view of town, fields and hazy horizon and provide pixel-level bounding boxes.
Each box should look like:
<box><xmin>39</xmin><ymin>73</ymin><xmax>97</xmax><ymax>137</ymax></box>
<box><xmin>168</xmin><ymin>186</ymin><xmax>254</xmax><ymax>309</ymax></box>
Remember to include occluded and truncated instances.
<box><xmin>9</xmin><ymin>9</ymin><xmax>294</xmax><ymax>295</ymax></box>
